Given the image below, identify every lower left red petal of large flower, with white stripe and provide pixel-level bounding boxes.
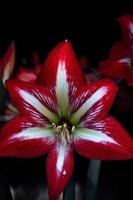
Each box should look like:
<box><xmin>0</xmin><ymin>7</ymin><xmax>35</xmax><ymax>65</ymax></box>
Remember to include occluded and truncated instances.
<box><xmin>0</xmin><ymin>116</ymin><xmax>55</xmax><ymax>157</ymax></box>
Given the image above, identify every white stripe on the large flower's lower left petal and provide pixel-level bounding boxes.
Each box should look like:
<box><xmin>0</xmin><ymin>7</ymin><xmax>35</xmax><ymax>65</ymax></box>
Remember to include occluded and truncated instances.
<box><xmin>10</xmin><ymin>127</ymin><xmax>54</xmax><ymax>141</ymax></box>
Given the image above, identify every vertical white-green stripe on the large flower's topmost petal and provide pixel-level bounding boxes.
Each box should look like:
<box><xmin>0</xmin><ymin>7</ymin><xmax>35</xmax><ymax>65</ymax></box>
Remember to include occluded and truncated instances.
<box><xmin>55</xmin><ymin>61</ymin><xmax>69</xmax><ymax>117</ymax></box>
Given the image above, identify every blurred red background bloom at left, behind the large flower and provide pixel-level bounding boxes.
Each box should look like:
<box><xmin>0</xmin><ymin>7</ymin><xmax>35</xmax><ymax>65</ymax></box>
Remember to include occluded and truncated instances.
<box><xmin>0</xmin><ymin>42</ymin><xmax>41</xmax><ymax>122</ymax></box>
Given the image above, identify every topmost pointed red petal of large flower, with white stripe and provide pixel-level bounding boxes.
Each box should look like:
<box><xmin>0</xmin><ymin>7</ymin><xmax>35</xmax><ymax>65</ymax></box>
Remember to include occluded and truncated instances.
<box><xmin>38</xmin><ymin>40</ymin><xmax>86</xmax><ymax>117</ymax></box>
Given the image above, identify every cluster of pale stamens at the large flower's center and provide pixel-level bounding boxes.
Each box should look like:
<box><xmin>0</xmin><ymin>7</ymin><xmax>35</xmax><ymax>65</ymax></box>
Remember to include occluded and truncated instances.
<box><xmin>52</xmin><ymin>123</ymin><xmax>75</xmax><ymax>144</ymax></box>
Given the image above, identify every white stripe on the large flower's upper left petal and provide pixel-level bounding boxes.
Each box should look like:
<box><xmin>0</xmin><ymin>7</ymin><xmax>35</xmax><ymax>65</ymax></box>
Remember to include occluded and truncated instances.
<box><xmin>19</xmin><ymin>90</ymin><xmax>58</xmax><ymax>123</ymax></box>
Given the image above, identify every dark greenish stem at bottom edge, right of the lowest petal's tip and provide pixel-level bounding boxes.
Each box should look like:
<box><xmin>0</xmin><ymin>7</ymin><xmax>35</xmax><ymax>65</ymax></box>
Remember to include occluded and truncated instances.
<box><xmin>63</xmin><ymin>178</ymin><xmax>75</xmax><ymax>200</ymax></box>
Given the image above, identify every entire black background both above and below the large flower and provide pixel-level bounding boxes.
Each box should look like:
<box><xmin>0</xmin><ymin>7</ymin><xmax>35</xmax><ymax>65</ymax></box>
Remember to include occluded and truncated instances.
<box><xmin>0</xmin><ymin>0</ymin><xmax>133</xmax><ymax>200</ymax></box>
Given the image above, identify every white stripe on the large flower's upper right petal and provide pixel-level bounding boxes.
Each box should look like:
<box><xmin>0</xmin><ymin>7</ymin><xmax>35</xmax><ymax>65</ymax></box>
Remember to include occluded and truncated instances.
<box><xmin>70</xmin><ymin>87</ymin><xmax>108</xmax><ymax>124</ymax></box>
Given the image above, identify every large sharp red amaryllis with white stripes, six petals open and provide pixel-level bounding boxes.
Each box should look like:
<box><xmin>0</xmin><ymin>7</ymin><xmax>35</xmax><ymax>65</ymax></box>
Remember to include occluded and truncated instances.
<box><xmin>0</xmin><ymin>41</ymin><xmax>133</xmax><ymax>200</ymax></box>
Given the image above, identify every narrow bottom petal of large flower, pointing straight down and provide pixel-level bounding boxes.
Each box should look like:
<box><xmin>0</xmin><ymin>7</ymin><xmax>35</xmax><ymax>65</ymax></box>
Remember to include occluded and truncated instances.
<box><xmin>46</xmin><ymin>143</ymin><xmax>73</xmax><ymax>200</ymax></box>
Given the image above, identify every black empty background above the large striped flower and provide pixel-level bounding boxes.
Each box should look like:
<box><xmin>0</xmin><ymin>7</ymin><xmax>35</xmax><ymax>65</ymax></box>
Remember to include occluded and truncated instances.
<box><xmin>0</xmin><ymin>0</ymin><xmax>133</xmax><ymax>63</ymax></box>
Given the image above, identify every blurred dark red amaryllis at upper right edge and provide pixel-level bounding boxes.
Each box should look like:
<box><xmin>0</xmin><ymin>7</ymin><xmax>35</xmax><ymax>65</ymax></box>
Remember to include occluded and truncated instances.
<box><xmin>99</xmin><ymin>15</ymin><xmax>133</xmax><ymax>86</ymax></box>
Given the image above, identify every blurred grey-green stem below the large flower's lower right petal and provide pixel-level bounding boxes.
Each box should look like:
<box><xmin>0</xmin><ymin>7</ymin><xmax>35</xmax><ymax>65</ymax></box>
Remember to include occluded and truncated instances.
<box><xmin>85</xmin><ymin>160</ymin><xmax>101</xmax><ymax>200</ymax></box>
